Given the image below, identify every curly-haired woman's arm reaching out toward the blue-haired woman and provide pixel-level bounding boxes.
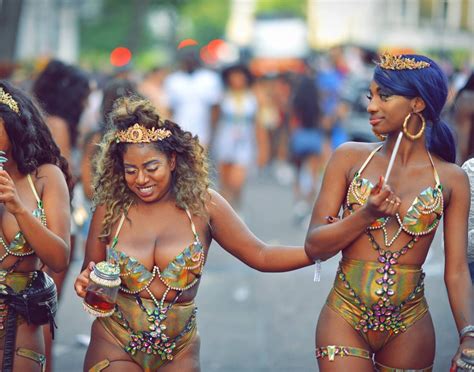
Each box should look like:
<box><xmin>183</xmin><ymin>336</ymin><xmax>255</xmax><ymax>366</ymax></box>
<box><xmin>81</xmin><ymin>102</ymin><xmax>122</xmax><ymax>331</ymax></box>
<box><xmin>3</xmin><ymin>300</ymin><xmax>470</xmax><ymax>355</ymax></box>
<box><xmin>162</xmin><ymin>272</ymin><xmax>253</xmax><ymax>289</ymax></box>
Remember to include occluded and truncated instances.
<box><xmin>208</xmin><ymin>190</ymin><xmax>313</xmax><ymax>272</ymax></box>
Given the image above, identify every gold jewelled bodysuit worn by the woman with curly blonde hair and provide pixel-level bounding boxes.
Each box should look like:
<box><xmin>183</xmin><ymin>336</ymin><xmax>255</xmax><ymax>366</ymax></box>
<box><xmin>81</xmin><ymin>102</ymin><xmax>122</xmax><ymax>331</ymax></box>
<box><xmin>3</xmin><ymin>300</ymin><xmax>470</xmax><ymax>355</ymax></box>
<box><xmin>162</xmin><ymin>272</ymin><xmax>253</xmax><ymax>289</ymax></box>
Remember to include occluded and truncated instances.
<box><xmin>95</xmin><ymin>211</ymin><xmax>205</xmax><ymax>371</ymax></box>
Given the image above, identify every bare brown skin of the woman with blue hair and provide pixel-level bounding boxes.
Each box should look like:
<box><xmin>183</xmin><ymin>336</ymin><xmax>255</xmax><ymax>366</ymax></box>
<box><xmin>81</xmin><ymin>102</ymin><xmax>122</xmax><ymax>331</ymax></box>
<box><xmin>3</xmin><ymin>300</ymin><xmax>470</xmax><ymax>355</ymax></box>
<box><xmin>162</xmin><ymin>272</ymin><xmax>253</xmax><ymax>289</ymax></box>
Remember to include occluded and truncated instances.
<box><xmin>305</xmin><ymin>82</ymin><xmax>474</xmax><ymax>371</ymax></box>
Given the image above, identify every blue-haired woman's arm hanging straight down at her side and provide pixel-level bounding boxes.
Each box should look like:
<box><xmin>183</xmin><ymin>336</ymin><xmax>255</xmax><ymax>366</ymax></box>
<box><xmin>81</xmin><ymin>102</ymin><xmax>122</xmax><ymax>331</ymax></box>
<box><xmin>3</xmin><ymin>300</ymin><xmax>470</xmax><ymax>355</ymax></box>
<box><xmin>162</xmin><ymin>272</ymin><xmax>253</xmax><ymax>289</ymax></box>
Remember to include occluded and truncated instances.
<box><xmin>444</xmin><ymin>169</ymin><xmax>474</xmax><ymax>366</ymax></box>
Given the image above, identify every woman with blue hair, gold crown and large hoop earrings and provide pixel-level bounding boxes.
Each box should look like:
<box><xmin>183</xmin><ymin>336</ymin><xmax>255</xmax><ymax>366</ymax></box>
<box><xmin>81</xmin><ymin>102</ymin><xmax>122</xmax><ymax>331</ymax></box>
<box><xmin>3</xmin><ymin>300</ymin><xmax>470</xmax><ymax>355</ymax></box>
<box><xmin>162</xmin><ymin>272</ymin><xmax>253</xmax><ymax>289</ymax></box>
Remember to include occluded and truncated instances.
<box><xmin>305</xmin><ymin>54</ymin><xmax>474</xmax><ymax>372</ymax></box>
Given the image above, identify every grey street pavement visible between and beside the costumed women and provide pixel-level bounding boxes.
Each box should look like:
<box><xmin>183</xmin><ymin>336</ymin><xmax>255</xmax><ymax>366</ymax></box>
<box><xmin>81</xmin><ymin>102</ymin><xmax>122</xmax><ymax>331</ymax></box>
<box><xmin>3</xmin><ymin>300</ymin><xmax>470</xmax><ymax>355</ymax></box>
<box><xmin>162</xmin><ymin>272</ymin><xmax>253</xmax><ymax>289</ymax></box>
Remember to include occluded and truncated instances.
<box><xmin>54</xmin><ymin>170</ymin><xmax>458</xmax><ymax>372</ymax></box>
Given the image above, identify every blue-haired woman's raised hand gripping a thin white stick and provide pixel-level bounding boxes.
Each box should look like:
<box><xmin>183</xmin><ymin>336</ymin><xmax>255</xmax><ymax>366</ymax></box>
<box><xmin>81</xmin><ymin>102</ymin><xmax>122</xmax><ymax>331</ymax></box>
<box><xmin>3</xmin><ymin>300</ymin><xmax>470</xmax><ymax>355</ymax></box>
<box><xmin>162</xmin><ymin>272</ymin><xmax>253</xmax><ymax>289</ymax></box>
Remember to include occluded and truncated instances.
<box><xmin>363</xmin><ymin>176</ymin><xmax>400</xmax><ymax>219</ymax></box>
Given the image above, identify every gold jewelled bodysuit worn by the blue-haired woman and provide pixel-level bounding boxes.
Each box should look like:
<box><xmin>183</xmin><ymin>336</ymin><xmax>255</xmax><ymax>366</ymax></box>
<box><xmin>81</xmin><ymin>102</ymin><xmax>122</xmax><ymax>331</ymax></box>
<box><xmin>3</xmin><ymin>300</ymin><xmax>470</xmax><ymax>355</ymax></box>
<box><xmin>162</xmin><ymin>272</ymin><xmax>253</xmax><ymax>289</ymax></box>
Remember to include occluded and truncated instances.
<box><xmin>327</xmin><ymin>146</ymin><xmax>443</xmax><ymax>352</ymax></box>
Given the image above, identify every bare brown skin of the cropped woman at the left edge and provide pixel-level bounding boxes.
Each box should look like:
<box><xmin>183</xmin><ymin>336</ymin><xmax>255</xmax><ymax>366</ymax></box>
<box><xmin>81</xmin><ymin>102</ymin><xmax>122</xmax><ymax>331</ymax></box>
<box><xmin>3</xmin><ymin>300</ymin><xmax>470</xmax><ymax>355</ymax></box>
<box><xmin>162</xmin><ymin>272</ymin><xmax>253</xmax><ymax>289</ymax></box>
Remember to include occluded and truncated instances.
<box><xmin>0</xmin><ymin>119</ymin><xmax>70</xmax><ymax>371</ymax></box>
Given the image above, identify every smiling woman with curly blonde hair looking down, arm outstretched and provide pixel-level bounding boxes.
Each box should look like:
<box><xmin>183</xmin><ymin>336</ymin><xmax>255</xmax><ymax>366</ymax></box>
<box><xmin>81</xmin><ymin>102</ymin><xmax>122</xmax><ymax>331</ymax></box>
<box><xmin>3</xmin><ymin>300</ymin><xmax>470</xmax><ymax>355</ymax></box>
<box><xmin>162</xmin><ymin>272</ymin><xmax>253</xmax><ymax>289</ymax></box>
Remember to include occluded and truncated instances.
<box><xmin>75</xmin><ymin>98</ymin><xmax>312</xmax><ymax>371</ymax></box>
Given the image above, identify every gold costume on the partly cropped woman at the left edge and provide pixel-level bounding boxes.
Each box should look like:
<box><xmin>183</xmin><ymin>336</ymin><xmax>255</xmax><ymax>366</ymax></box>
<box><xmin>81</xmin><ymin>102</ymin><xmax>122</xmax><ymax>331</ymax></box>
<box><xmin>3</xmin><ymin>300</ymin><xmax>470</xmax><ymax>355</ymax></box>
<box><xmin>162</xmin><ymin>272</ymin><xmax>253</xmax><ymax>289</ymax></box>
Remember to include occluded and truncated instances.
<box><xmin>0</xmin><ymin>174</ymin><xmax>46</xmax><ymax>371</ymax></box>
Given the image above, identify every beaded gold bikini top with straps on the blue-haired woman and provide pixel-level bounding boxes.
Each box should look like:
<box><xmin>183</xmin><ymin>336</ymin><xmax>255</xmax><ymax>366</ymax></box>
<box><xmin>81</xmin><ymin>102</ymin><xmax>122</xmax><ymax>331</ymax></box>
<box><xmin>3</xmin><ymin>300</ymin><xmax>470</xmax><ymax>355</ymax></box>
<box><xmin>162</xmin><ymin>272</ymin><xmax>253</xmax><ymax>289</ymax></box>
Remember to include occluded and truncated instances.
<box><xmin>344</xmin><ymin>146</ymin><xmax>444</xmax><ymax>238</ymax></box>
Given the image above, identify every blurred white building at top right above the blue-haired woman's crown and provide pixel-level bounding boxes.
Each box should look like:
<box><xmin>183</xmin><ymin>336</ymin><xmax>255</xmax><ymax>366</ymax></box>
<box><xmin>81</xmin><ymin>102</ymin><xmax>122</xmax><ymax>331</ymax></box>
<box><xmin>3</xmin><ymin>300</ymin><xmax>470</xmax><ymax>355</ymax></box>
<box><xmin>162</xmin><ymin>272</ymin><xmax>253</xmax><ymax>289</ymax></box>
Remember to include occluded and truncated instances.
<box><xmin>307</xmin><ymin>0</ymin><xmax>474</xmax><ymax>54</ymax></box>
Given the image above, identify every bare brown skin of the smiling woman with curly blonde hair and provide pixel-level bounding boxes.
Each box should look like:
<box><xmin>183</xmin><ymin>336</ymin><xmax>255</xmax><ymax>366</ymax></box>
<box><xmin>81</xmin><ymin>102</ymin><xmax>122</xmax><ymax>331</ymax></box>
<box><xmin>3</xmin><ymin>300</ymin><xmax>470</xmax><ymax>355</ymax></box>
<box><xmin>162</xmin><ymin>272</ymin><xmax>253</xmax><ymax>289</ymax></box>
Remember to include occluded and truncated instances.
<box><xmin>74</xmin><ymin>144</ymin><xmax>312</xmax><ymax>371</ymax></box>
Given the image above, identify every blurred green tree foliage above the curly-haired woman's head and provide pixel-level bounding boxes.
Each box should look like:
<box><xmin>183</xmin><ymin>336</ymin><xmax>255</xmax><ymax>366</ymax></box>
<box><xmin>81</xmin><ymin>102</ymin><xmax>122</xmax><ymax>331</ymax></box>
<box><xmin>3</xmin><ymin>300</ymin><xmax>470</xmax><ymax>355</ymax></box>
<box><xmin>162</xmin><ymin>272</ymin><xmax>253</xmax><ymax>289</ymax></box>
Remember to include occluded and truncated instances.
<box><xmin>81</xmin><ymin>0</ymin><xmax>229</xmax><ymax>69</ymax></box>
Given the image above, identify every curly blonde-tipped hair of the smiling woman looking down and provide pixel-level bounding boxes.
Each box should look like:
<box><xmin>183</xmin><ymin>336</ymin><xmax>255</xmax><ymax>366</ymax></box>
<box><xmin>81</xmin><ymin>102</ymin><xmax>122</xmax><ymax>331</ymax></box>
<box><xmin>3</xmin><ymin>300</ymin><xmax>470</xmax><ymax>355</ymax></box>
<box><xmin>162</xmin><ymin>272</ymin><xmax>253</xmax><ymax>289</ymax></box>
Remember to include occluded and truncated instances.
<box><xmin>93</xmin><ymin>97</ymin><xmax>209</xmax><ymax>240</ymax></box>
